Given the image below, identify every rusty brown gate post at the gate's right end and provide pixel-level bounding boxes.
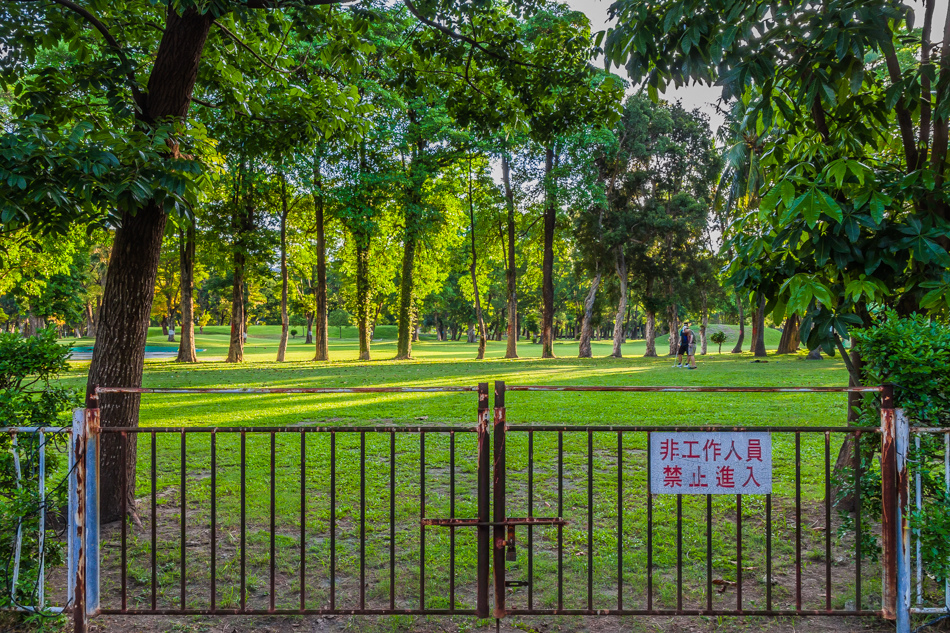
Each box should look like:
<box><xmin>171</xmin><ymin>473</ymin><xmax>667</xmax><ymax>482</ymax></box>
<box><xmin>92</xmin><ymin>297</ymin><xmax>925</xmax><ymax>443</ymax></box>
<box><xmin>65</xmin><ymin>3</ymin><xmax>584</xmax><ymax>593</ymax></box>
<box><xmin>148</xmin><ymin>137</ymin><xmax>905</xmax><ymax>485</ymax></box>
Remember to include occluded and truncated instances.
<box><xmin>880</xmin><ymin>385</ymin><xmax>898</xmax><ymax>620</ymax></box>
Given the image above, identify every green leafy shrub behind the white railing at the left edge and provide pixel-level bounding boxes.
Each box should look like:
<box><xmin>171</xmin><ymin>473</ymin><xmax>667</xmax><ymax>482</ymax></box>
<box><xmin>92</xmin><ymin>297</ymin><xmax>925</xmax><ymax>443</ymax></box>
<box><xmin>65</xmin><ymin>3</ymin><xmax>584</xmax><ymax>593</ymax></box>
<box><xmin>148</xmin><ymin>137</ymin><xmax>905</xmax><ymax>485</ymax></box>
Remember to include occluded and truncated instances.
<box><xmin>0</xmin><ymin>328</ymin><xmax>79</xmax><ymax>607</ymax></box>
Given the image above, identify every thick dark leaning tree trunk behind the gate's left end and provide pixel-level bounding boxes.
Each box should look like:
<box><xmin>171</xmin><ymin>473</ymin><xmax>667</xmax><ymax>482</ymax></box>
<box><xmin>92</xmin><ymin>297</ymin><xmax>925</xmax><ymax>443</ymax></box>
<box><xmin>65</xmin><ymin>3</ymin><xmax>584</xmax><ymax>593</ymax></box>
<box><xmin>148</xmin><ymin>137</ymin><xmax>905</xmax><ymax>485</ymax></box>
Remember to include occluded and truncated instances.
<box><xmin>86</xmin><ymin>10</ymin><xmax>213</xmax><ymax>523</ymax></box>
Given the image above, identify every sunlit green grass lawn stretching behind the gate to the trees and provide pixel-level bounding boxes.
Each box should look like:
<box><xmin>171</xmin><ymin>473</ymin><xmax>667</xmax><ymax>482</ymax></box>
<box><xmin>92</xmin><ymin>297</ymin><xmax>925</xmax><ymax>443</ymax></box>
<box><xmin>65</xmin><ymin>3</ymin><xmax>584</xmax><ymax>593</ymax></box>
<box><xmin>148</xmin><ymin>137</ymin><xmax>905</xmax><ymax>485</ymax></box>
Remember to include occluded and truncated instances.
<box><xmin>50</xmin><ymin>326</ymin><xmax>892</xmax><ymax>628</ymax></box>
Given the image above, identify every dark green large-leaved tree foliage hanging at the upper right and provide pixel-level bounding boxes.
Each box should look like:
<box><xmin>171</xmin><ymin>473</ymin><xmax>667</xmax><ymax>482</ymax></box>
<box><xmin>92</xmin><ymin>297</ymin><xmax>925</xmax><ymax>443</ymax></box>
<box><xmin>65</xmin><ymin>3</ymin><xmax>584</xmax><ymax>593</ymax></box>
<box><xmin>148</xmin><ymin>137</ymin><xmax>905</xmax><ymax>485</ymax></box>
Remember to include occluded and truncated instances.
<box><xmin>606</xmin><ymin>0</ymin><xmax>950</xmax><ymax>352</ymax></box>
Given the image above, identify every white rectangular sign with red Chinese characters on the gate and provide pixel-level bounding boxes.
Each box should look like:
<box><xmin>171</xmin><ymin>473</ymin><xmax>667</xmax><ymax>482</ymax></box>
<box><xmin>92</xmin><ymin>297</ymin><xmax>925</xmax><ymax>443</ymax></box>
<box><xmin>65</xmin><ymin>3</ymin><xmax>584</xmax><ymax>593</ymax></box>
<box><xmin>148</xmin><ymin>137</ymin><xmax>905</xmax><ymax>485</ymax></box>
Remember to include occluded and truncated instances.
<box><xmin>650</xmin><ymin>431</ymin><xmax>772</xmax><ymax>495</ymax></box>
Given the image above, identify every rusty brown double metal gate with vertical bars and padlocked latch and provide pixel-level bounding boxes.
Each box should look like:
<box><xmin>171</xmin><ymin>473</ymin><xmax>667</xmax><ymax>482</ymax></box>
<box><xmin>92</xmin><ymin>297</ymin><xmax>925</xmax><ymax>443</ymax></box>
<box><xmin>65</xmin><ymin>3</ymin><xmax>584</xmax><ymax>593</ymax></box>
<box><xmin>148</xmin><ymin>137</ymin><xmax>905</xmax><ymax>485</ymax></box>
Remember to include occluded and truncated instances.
<box><xmin>0</xmin><ymin>382</ymin><xmax>924</xmax><ymax>631</ymax></box>
